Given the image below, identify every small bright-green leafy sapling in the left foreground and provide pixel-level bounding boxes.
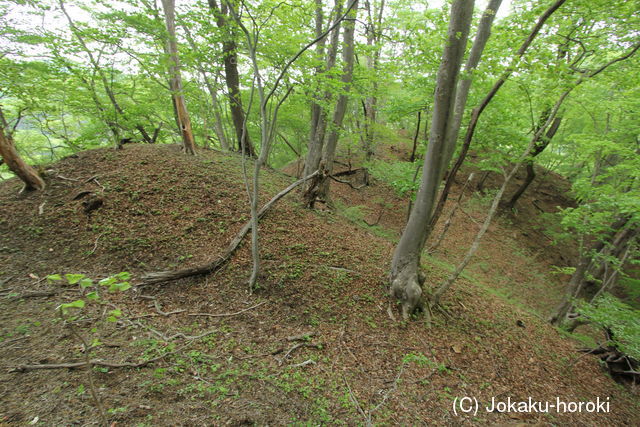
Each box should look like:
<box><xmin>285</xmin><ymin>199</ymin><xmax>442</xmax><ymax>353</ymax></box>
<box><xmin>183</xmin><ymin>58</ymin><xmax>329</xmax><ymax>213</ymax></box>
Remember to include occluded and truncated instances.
<box><xmin>47</xmin><ymin>272</ymin><xmax>131</xmax><ymax>425</ymax></box>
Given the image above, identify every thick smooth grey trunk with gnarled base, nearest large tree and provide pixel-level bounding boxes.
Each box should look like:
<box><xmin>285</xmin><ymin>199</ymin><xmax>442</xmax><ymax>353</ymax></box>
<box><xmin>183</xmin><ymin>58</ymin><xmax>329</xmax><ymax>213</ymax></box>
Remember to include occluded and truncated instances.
<box><xmin>390</xmin><ymin>0</ymin><xmax>474</xmax><ymax>319</ymax></box>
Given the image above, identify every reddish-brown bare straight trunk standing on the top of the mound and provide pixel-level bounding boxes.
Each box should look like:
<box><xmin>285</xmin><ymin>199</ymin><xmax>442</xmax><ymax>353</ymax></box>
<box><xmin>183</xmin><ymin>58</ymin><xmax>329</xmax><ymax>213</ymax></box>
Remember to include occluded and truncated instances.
<box><xmin>162</xmin><ymin>0</ymin><xmax>196</xmax><ymax>155</ymax></box>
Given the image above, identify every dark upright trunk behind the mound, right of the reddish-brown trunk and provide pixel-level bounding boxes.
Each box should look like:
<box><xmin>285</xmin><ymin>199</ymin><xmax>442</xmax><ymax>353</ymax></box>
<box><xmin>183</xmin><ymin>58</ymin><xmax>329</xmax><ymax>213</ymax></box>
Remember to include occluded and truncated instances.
<box><xmin>209</xmin><ymin>0</ymin><xmax>256</xmax><ymax>157</ymax></box>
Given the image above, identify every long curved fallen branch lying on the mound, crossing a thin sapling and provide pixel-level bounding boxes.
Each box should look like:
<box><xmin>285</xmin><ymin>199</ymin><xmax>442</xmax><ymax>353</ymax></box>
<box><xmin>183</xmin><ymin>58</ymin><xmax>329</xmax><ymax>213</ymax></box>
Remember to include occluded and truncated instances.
<box><xmin>141</xmin><ymin>171</ymin><xmax>318</xmax><ymax>285</ymax></box>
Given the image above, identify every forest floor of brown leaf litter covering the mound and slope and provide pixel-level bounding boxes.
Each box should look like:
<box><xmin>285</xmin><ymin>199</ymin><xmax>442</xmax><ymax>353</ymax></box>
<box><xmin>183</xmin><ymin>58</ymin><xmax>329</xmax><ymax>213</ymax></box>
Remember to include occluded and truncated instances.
<box><xmin>0</xmin><ymin>145</ymin><xmax>640</xmax><ymax>426</ymax></box>
